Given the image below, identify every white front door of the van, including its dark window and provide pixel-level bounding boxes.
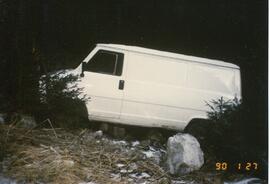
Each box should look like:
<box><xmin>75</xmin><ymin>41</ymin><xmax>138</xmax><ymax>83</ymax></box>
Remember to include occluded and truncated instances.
<box><xmin>81</xmin><ymin>50</ymin><xmax>124</xmax><ymax>119</ymax></box>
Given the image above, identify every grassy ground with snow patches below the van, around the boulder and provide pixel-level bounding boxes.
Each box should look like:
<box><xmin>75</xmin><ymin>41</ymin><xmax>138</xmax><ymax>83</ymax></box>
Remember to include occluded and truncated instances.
<box><xmin>0</xmin><ymin>125</ymin><xmax>266</xmax><ymax>184</ymax></box>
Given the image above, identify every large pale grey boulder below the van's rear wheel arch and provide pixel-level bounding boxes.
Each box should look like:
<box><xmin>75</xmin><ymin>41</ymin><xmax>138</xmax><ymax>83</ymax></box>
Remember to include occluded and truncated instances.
<box><xmin>166</xmin><ymin>133</ymin><xmax>204</xmax><ymax>175</ymax></box>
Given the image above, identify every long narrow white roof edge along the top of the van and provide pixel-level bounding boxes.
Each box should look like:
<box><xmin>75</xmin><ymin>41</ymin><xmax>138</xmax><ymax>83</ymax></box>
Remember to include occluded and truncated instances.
<box><xmin>97</xmin><ymin>44</ymin><xmax>239</xmax><ymax>69</ymax></box>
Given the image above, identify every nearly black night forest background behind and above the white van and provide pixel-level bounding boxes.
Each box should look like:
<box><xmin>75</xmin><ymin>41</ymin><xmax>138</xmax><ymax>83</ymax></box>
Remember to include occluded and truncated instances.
<box><xmin>0</xmin><ymin>0</ymin><xmax>268</xmax><ymax>172</ymax></box>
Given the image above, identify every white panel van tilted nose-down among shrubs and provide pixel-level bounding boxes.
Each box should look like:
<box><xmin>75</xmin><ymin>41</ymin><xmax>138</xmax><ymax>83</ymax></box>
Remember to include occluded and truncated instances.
<box><xmin>74</xmin><ymin>44</ymin><xmax>241</xmax><ymax>130</ymax></box>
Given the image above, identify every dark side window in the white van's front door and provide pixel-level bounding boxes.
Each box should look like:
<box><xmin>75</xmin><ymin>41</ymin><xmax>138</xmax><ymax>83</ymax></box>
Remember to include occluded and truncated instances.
<box><xmin>86</xmin><ymin>50</ymin><xmax>124</xmax><ymax>76</ymax></box>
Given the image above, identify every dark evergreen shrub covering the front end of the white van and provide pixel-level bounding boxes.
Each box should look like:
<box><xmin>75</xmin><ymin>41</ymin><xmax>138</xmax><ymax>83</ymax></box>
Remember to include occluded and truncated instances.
<box><xmin>37</xmin><ymin>71</ymin><xmax>89</xmax><ymax>128</ymax></box>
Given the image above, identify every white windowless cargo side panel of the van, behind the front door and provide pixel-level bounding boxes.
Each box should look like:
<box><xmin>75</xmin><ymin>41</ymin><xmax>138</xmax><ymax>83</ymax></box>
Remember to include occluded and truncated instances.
<box><xmin>120</xmin><ymin>52</ymin><xmax>235</xmax><ymax>130</ymax></box>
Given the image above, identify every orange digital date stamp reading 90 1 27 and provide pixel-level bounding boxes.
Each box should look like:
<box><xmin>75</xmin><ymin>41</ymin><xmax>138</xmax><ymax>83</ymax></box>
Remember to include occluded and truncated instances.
<box><xmin>216</xmin><ymin>162</ymin><xmax>259</xmax><ymax>171</ymax></box>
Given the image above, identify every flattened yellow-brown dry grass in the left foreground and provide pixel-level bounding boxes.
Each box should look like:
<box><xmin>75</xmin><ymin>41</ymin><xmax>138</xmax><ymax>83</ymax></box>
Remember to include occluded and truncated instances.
<box><xmin>0</xmin><ymin>125</ymin><xmax>169</xmax><ymax>184</ymax></box>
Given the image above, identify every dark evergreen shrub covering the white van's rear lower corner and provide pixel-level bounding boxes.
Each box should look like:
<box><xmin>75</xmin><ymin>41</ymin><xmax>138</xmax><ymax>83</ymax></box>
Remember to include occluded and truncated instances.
<box><xmin>206</xmin><ymin>97</ymin><xmax>246</xmax><ymax>158</ymax></box>
